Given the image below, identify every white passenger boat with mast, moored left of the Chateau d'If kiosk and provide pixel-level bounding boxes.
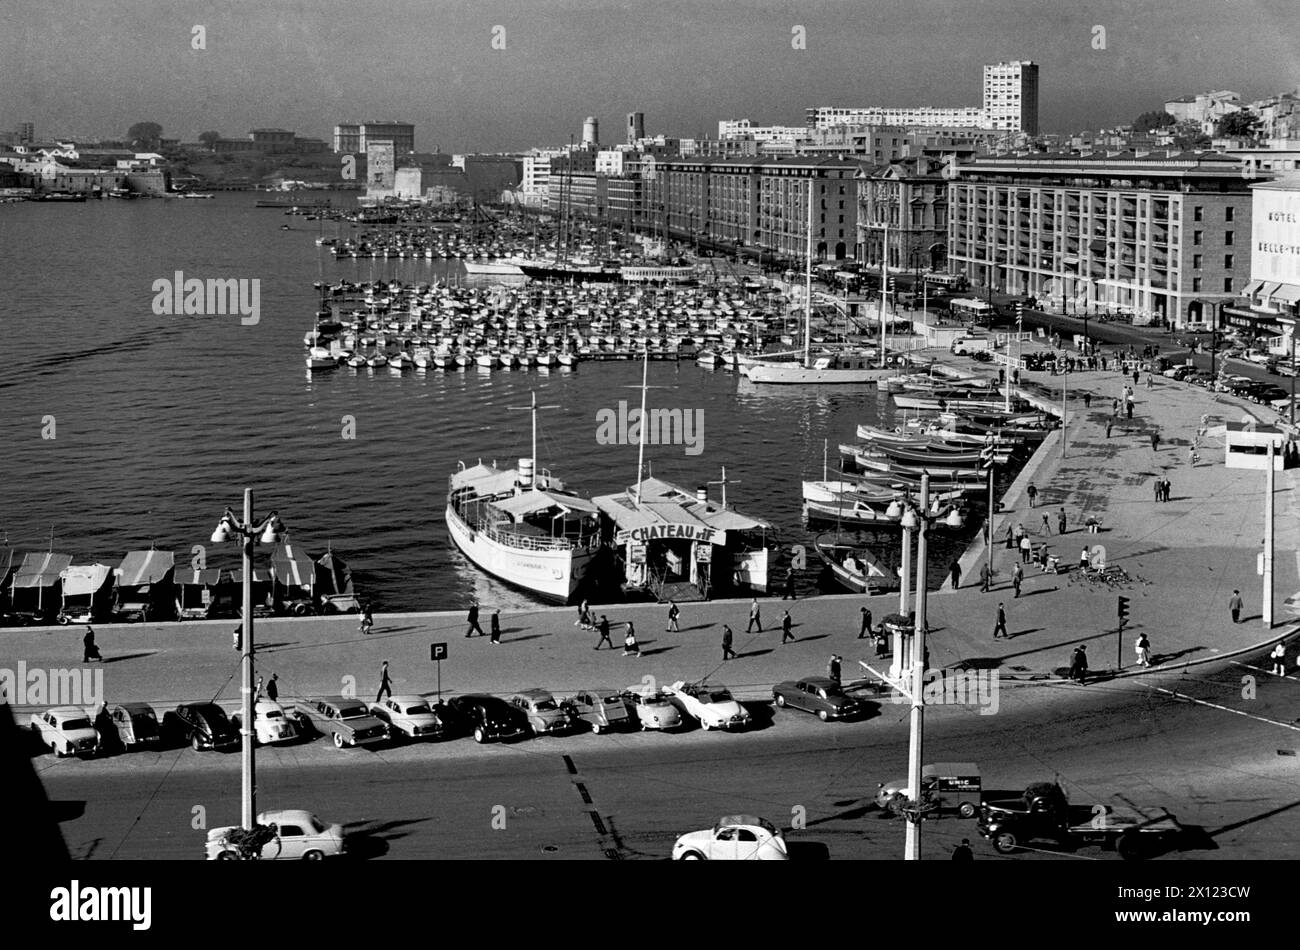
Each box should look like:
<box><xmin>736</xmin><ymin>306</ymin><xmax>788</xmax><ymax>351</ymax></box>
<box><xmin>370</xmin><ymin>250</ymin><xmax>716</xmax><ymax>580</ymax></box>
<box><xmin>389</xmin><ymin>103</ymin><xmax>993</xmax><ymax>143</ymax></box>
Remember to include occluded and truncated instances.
<box><xmin>445</xmin><ymin>392</ymin><xmax>601</xmax><ymax>603</ymax></box>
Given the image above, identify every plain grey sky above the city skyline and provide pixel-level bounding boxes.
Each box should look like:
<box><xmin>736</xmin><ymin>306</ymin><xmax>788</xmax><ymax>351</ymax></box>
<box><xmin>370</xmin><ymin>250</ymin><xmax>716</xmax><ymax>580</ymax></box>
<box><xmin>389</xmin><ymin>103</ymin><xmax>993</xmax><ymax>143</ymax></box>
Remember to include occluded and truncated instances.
<box><xmin>0</xmin><ymin>0</ymin><xmax>1300</xmax><ymax>152</ymax></box>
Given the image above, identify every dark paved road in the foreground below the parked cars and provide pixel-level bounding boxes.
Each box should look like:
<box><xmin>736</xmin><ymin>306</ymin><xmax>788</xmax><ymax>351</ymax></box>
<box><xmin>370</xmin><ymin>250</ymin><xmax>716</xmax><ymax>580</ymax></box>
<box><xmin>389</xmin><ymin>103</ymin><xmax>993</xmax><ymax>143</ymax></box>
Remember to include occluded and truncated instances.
<box><xmin>34</xmin><ymin>647</ymin><xmax>1300</xmax><ymax>860</ymax></box>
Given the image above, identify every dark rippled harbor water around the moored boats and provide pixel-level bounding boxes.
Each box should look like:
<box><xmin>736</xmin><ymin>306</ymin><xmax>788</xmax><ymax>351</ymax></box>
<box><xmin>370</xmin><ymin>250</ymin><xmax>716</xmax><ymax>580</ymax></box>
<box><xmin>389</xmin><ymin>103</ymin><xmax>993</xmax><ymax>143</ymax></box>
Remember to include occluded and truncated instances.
<box><xmin>0</xmin><ymin>192</ymin><xmax>954</xmax><ymax>611</ymax></box>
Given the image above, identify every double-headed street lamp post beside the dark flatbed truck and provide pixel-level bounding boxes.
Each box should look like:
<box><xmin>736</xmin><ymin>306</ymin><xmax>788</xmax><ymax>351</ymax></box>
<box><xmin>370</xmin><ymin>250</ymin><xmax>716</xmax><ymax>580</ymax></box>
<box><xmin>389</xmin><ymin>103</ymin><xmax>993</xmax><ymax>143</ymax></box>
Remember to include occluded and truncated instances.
<box><xmin>872</xmin><ymin>472</ymin><xmax>966</xmax><ymax>860</ymax></box>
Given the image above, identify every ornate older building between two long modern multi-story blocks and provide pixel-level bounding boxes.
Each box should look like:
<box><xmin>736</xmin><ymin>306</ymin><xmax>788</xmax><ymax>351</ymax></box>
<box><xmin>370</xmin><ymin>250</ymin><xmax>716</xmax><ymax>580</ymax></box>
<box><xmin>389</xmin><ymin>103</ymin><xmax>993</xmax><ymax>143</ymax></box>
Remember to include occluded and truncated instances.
<box><xmin>857</xmin><ymin>157</ymin><xmax>948</xmax><ymax>273</ymax></box>
